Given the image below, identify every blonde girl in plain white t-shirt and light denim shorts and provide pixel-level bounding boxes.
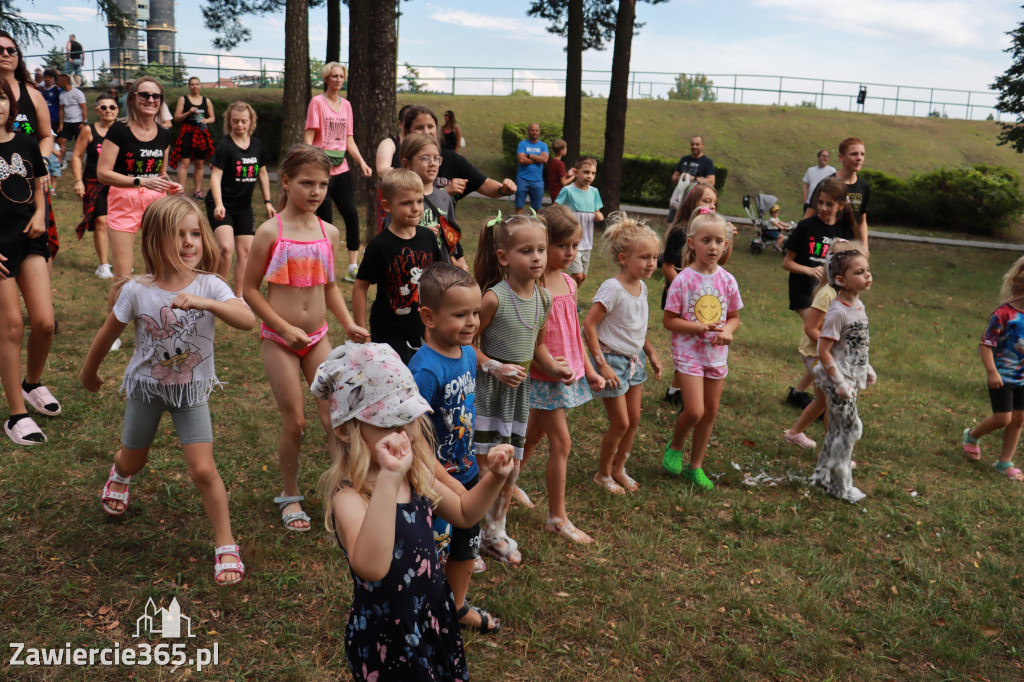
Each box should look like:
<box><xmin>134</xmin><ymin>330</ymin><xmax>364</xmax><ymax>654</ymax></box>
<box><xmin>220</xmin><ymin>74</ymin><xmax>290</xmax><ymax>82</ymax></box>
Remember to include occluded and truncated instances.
<box><xmin>583</xmin><ymin>213</ymin><xmax>662</xmax><ymax>495</ymax></box>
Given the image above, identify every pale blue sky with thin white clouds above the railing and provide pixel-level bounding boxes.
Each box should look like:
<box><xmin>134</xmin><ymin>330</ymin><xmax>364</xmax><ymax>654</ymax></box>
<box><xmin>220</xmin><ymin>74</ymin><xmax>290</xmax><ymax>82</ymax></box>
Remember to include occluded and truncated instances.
<box><xmin>15</xmin><ymin>0</ymin><xmax>1024</xmax><ymax>118</ymax></box>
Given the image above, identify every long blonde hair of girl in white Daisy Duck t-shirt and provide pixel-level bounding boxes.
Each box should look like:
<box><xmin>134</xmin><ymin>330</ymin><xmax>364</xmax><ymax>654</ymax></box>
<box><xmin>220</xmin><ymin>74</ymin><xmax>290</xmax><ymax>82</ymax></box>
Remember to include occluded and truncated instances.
<box><xmin>139</xmin><ymin>197</ymin><xmax>220</xmax><ymax>283</ymax></box>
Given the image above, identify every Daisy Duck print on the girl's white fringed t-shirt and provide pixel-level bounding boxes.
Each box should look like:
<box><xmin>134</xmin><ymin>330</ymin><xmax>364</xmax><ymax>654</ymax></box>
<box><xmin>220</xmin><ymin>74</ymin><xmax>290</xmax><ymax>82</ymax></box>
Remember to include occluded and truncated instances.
<box><xmin>139</xmin><ymin>305</ymin><xmax>213</xmax><ymax>386</ymax></box>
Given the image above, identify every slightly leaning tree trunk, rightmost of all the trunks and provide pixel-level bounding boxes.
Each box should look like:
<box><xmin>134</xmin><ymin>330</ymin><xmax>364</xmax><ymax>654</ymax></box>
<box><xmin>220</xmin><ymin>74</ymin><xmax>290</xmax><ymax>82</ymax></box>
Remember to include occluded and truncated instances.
<box><xmin>601</xmin><ymin>0</ymin><xmax>637</xmax><ymax>210</ymax></box>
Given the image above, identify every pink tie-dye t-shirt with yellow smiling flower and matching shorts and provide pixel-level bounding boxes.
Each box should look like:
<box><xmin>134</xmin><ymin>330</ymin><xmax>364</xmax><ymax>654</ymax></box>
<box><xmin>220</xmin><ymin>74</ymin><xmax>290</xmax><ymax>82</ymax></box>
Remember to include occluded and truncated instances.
<box><xmin>665</xmin><ymin>267</ymin><xmax>743</xmax><ymax>367</ymax></box>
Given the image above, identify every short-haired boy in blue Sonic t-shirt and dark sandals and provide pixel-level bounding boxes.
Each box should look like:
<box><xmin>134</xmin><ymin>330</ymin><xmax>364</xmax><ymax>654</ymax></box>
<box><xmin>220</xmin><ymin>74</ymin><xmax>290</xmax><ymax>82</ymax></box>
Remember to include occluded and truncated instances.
<box><xmin>409</xmin><ymin>263</ymin><xmax>501</xmax><ymax>635</ymax></box>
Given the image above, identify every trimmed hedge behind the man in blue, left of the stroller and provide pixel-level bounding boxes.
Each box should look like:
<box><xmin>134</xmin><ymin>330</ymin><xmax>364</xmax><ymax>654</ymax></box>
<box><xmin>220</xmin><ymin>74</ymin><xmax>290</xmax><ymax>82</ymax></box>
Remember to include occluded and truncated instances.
<box><xmin>502</xmin><ymin>123</ymin><xmax>729</xmax><ymax>210</ymax></box>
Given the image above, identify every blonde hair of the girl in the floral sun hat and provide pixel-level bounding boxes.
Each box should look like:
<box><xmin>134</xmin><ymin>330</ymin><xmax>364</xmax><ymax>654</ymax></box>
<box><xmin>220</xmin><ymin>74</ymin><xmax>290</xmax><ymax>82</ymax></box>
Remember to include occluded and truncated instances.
<box><xmin>319</xmin><ymin>416</ymin><xmax>441</xmax><ymax>532</ymax></box>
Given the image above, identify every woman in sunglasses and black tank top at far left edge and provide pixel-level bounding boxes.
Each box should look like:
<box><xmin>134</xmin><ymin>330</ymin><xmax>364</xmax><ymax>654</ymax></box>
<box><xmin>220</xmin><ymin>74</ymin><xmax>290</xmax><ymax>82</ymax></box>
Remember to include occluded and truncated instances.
<box><xmin>0</xmin><ymin>31</ymin><xmax>59</xmax><ymax>258</ymax></box>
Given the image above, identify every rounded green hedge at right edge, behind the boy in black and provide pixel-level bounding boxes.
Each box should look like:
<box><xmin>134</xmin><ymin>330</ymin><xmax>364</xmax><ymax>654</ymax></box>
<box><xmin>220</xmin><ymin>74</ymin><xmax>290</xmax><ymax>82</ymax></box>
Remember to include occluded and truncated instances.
<box><xmin>860</xmin><ymin>164</ymin><xmax>1024</xmax><ymax>236</ymax></box>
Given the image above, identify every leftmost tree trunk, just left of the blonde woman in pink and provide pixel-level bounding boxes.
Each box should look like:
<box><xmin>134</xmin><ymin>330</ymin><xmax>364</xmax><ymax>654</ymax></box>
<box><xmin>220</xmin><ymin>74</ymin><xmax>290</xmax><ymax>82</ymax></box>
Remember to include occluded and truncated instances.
<box><xmin>281</xmin><ymin>0</ymin><xmax>309</xmax><ymax>158</ymax></box>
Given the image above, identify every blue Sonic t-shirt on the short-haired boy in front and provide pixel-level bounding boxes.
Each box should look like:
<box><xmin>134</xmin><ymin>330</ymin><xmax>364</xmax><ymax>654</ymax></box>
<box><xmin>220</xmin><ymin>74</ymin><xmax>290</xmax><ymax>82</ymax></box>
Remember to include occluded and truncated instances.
<box><xmin>409</xmin><ymin>344</ymin><xmax>479</xmax><ymax>484</ymax></box>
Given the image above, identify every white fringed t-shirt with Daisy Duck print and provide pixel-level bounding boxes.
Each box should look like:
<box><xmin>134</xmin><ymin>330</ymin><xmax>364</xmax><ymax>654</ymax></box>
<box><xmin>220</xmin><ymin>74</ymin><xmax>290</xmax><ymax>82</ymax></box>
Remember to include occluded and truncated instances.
<box><xmin>114</xmin><ymin>273</ymin><xmax>234</xmax><ymax>407</ymax></box>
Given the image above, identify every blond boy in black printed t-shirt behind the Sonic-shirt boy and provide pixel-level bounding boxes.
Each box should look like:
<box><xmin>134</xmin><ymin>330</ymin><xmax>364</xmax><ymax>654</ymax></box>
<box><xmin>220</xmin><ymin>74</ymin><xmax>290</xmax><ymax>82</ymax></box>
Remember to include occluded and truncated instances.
<box><xmin>352</xmin><ymin>169</ymin><xmax>441</xmax><ymax>365</ymax></box>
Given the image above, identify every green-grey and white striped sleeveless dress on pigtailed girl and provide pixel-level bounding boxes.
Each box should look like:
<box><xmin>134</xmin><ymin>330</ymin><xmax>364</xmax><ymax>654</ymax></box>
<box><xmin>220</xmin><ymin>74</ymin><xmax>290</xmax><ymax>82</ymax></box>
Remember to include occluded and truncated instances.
<box><xmin>474</xmin><ymin>280</ymin><xmax>551</xmax><ymax>459</ymax></box>
